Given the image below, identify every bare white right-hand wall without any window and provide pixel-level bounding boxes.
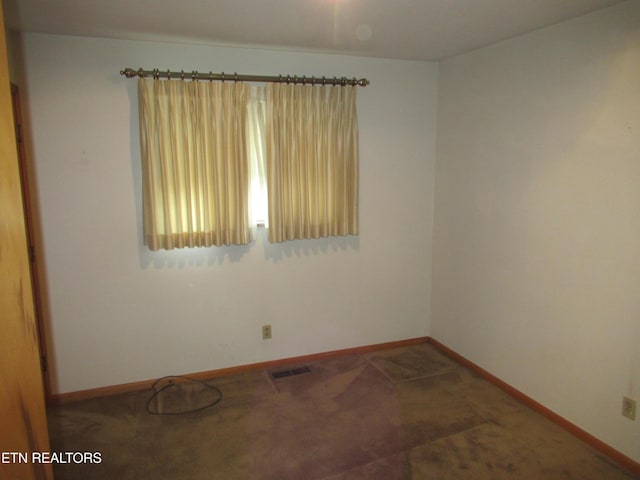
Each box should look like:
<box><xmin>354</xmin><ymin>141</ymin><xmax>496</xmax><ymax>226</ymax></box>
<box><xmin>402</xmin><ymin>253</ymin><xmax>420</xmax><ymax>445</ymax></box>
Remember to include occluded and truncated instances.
<box><xmin>430</xmin><ymin>2</ymin><xmax>640</xmax><ymax>461</ymax></box>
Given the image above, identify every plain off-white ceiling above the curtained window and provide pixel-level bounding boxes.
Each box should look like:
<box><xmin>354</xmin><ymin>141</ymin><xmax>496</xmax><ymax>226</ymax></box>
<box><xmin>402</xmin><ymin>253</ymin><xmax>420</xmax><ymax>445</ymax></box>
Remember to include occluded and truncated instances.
<box><xmin>3</xmin><ymin>0</ymin><xmax>633</xmax><ymax>60</ymax></box>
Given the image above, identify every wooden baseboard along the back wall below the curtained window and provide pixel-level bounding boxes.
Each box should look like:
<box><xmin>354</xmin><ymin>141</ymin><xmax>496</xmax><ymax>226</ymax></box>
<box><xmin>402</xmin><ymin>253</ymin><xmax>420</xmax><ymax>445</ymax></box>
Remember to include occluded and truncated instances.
<box><xmin>49</xmin><ymin>337</ymin><xmax>429</xmax><ymax>405</ymax></box>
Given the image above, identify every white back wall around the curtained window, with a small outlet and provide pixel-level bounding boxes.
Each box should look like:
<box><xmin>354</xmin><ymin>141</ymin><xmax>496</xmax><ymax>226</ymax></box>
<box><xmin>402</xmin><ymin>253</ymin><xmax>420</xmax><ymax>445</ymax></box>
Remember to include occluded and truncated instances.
<box><xmin>15</xmin><ymin>34</ymin><xmax>437</xmax><ymax>393</ymax></box>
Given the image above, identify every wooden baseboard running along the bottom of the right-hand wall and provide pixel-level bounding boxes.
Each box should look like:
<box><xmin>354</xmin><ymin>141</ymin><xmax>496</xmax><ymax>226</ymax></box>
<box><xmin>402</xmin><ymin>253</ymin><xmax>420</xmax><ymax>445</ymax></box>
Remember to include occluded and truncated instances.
<box><xmin>427</xmin><ymin>337</ymin><xmax>640</xmax><ymax>476</ymax></box>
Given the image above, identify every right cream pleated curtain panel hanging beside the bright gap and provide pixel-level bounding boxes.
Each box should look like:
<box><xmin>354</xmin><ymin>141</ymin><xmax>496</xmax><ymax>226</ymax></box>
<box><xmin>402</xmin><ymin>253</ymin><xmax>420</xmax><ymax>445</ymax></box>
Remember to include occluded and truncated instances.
<box><xmin>265</xmin><ymin>83</ymin><xmax>358</xmax><ymax>242</ymax></box>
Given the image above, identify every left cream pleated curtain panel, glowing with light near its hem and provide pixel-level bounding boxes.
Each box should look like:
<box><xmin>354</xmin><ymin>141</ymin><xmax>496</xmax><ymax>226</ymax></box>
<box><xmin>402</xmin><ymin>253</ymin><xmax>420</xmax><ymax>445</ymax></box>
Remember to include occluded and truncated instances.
<box><xmin>138</xmin><ymin>79</ymin><xmax>251</xmax><ymax>250</ymax></box>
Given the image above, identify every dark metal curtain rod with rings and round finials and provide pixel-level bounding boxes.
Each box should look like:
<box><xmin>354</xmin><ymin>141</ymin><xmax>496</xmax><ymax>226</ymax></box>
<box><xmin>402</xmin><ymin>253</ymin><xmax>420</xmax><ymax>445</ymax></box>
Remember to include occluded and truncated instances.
<box><xmin>120</xmin><ymin>68</ymin><xmax>369</xmax><ymax>87</ymax></box>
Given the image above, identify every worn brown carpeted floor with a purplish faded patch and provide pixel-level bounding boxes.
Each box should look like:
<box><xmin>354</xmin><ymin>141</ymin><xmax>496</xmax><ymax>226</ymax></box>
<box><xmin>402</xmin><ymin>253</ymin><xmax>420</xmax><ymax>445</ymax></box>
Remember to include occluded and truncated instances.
<box><xmin>48</xmin><ymin>344</ymin><xmax>634</xmax><ymax>480</ymax></box>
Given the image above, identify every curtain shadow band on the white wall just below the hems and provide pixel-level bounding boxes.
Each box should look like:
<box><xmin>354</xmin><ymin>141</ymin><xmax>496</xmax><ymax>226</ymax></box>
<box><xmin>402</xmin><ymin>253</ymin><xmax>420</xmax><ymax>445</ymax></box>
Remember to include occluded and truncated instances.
<box><xmin>138</xmin><ymin>229</ymin><xmax>360</xmax><ymax>269</ymax></box>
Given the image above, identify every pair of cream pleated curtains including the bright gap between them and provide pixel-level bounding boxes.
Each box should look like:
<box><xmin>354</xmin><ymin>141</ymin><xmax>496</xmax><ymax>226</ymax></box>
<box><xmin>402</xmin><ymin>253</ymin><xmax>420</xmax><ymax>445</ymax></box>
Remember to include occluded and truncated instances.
<box><xmin>138</xmin><ymin>78</ymin><xmax>358</xmax><ymax>250</ymax></box>
